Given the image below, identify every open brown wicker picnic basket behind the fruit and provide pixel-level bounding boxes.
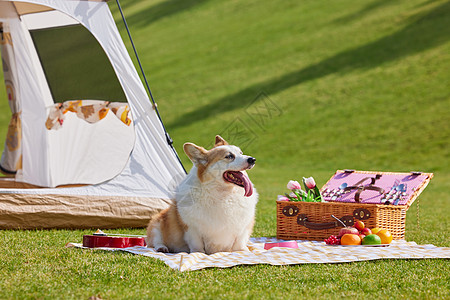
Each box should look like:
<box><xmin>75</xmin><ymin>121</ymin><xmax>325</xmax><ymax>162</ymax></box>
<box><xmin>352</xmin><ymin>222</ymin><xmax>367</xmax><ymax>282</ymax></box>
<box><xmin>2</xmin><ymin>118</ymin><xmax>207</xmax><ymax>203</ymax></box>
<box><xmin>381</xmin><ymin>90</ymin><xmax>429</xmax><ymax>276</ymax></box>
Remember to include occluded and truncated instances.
<box><xmin>277</xmin><ymin>170</ymin><xmax>433</xmax><ymax>241</ymax></box>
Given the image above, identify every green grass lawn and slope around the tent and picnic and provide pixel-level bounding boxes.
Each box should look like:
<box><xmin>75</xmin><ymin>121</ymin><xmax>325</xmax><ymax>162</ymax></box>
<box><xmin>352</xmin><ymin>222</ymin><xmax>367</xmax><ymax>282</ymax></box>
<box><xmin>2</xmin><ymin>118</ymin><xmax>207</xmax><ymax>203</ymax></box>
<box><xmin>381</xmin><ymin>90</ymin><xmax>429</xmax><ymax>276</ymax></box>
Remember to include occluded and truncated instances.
<box><xmin>0</xmin><ymin>0</ymin><xmax>450</xmax><ymax>299</ymax></box>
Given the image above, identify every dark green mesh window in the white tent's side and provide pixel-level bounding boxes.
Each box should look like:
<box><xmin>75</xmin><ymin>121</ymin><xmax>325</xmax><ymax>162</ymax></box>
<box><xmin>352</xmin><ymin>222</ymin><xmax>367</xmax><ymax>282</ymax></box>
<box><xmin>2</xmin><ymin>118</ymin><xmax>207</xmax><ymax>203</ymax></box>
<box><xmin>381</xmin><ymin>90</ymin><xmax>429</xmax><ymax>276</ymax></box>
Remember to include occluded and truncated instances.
<box><xmin>31</xmin><ymin>25</ymin><xmax>126</xmax><ymax>102</ymax></box>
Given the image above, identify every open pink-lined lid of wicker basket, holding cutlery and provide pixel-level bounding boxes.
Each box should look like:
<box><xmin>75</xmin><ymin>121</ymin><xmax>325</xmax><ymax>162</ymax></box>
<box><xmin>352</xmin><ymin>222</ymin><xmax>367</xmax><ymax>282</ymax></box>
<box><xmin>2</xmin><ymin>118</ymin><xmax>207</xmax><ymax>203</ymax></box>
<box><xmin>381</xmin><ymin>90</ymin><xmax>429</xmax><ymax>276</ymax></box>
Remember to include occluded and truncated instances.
<box><xmin>320</xmin><ymin>170</ymin><xmax>433</xmax><ymax>207</ymax></box>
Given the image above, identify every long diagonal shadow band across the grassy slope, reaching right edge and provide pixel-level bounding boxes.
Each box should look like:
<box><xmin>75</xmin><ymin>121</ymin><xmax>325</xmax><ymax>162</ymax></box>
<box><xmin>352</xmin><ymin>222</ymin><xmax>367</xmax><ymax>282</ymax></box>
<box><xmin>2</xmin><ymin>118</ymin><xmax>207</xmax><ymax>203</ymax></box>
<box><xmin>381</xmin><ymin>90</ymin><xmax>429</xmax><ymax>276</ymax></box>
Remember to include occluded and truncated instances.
<box><xmin>168</xmin><ymin>2</ymin><xmax>450</xmax><ymax>128</ymax></box>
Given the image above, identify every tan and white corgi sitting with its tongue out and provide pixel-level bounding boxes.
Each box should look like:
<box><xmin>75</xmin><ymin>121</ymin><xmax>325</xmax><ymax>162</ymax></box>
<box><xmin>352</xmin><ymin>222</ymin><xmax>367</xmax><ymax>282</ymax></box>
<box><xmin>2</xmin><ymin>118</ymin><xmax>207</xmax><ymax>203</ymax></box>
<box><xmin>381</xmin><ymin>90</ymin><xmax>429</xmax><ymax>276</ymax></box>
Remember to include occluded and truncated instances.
<box><xmin>146</xmin><ymin>136</ymin><xmax>258</xmax><ymax>254</ymax></box>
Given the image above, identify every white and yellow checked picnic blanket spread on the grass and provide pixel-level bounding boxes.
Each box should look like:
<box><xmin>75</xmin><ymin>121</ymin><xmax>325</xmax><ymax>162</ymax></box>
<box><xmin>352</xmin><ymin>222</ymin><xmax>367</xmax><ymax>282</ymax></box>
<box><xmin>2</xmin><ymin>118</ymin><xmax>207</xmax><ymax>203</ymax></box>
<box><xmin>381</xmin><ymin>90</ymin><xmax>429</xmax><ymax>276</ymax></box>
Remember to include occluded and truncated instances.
<box><xmin>66</xmin><ymin>237</ymin><xmax>450</xmax><ymax>272</ymax></box>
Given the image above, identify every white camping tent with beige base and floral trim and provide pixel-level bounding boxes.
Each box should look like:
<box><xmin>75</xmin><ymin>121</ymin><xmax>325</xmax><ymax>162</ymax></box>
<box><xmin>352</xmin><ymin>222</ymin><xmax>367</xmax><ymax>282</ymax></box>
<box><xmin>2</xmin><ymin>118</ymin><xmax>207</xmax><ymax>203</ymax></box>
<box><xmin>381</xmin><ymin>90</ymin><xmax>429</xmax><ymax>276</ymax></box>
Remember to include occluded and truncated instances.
<box><xmin>0</xmin><ymin>0</ymin><xmax>185</xmax><ymax>228</ymax></box>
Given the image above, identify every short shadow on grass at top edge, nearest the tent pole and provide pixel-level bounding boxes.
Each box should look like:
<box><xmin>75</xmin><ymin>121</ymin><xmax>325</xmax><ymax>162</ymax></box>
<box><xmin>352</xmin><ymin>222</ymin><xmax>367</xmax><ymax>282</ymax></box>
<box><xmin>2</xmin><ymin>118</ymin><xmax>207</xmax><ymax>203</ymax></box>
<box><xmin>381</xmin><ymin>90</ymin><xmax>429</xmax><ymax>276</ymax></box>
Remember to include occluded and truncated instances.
<box><xmin>127</xmin><ymin>0</ymin><xmax>209</xmax><ymax>27</ymax></box>
